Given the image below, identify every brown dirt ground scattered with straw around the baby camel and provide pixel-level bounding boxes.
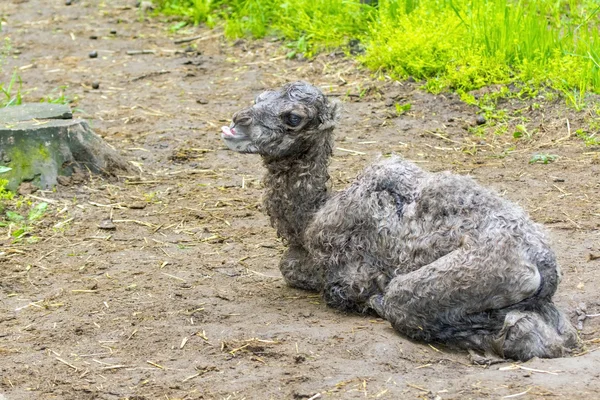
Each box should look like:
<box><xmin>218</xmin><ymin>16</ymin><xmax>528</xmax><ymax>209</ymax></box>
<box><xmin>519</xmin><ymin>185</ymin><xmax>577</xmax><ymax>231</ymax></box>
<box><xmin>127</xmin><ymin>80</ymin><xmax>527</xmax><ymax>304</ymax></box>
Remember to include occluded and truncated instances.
<box><xmin>0</xmin><ymin>0</ymin><xmax>600</xmax><ymax>400</ymax></box>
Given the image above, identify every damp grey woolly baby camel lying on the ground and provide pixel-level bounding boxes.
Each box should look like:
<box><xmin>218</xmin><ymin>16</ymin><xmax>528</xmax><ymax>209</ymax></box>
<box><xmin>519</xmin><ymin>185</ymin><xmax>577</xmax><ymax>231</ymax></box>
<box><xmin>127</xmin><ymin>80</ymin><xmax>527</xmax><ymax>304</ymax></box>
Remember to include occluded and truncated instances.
<box><xmin>222</xmin><ymin>82</ymin><xmax>579</xmax><ymax>360</ymax></box>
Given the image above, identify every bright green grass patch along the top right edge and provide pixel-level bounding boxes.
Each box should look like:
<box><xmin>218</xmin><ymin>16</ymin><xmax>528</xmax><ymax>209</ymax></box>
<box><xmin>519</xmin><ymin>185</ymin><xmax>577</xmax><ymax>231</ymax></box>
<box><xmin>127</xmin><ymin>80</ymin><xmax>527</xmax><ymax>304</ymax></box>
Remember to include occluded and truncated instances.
<box><xmin>158</xmin><ymin>0</ymin><xmax>600</xmax><ymax>101</ymax></box>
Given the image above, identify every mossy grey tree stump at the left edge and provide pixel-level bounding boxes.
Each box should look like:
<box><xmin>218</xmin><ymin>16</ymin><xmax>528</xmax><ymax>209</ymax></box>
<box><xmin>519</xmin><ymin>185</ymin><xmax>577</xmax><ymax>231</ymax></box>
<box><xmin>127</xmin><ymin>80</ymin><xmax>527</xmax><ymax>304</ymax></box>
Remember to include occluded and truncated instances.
<box><xmin>0</xmin><ymin>104</ymin><xmax>131</xmax><ymax>191</ymax></box>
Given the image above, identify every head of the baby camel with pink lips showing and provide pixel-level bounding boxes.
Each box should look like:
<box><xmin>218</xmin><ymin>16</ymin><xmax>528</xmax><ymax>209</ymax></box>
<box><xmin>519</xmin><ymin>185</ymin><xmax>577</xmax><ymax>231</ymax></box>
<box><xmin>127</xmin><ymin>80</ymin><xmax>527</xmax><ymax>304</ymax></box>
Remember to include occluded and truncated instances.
<box><xmin>221</xmin><ymin>81</ymin><xmax>339</xmax><ymax>159</ymax></box>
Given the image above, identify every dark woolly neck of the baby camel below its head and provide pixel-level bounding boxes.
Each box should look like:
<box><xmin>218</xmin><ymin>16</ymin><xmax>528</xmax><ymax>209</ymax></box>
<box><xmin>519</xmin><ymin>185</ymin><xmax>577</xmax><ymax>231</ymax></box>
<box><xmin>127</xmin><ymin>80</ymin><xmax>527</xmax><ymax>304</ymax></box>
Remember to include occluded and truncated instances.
<box><xmin>264</xmin><ymin>136</ymin><xmax>332</xmax><ymax>246</ymax></box>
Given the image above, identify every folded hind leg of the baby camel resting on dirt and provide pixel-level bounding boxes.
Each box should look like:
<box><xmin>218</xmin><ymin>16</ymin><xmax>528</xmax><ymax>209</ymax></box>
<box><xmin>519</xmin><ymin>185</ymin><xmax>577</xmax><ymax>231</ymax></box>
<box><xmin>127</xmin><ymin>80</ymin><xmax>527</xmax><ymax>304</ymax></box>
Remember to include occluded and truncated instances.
<box><xmin>370</xmin><ymin>239</ymin><xmax>576</xmax><ymax>360</ymax></box>
